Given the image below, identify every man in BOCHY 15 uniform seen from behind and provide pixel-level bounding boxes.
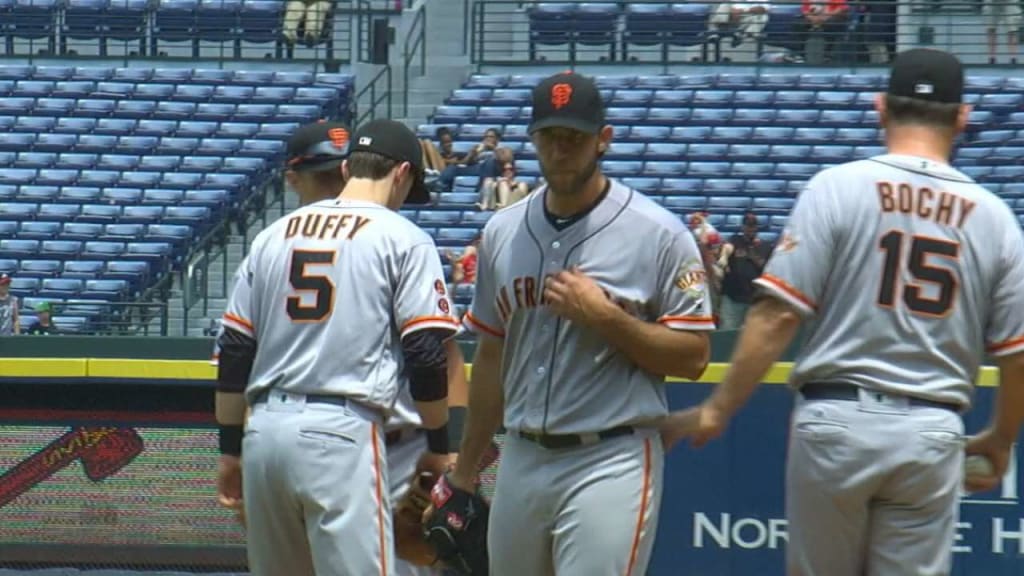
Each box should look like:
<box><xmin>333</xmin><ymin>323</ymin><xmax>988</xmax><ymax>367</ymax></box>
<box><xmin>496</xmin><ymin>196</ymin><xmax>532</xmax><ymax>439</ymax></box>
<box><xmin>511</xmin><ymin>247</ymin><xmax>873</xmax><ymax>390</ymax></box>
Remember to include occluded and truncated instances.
<box><xmin>666</xmin><ymin>49</ymin><xmax>1024</xmax><ymax>576</ymax></box>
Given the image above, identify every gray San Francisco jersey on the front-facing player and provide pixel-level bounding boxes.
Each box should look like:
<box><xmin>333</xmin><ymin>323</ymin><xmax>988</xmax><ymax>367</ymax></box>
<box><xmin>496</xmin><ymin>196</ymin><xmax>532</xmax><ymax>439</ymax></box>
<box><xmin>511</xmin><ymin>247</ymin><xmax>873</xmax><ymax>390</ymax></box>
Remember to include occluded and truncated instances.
<box><xmin>464</xmin><ymin>180</ymin><xmax>714</xmax><ymax>434</ymax></box>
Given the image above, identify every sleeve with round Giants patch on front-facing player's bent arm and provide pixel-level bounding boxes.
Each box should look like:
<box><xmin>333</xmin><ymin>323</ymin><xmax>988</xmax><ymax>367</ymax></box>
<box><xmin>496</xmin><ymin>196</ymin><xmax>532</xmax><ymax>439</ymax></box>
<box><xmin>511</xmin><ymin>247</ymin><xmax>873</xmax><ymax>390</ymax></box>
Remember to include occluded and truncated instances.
<box><xmin>654</xmin><ymin>228</ymin><xmax>715</xmax><ymax>330</ymax></box>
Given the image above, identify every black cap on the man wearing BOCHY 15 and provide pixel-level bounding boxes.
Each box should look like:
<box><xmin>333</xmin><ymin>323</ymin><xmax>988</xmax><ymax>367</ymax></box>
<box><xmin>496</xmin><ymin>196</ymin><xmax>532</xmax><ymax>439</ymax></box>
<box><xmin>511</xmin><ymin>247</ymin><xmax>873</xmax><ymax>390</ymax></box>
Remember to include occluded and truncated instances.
<box><xmin>889</xmin><ymin>48</ymin><xmax>964</xmax><ymax>104</ymax></box>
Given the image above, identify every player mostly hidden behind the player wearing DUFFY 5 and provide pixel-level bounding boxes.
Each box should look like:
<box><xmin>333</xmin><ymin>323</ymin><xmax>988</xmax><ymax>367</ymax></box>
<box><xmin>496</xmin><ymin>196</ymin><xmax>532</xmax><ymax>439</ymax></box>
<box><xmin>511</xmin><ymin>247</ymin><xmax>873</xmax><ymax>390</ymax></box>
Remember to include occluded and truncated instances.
<box><xmin>211</xmin><ymin>122</ymin><xmax>467</xmax><ymax>576</ymax></box>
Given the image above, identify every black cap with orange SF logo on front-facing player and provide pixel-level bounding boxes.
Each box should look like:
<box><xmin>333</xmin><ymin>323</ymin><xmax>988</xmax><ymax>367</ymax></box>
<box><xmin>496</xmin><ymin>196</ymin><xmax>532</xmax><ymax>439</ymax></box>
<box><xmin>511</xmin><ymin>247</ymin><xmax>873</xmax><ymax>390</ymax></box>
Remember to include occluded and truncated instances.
<box><xmin>529</xmin><ymin>72</ymin><xmax>604</xmax><ymax>134</ymax></box>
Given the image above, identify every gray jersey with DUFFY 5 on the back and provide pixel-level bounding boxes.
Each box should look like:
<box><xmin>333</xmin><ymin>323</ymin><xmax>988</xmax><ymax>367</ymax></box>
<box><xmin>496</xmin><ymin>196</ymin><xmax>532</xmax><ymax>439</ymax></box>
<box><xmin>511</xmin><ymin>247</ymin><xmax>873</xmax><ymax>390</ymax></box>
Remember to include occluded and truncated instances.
<box><xmin>223</xmin><ymin>195</ymin><xmax>458</xmax><ymax>413</ymax></box>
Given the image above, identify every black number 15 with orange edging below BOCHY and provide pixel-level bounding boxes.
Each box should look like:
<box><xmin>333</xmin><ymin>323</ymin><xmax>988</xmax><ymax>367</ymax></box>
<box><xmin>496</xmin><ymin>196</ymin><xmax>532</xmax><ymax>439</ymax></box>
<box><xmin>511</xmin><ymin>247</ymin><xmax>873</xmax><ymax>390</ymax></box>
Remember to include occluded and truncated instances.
<box><xmin>879</xmin><ymin>230</ymin><xmax>959</xmax><ymax>317</ymax></box>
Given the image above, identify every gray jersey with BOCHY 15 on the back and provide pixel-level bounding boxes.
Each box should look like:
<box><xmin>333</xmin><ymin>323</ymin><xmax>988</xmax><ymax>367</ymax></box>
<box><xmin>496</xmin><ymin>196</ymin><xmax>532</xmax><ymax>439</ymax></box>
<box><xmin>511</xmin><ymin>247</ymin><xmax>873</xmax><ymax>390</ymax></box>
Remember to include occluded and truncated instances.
<box><xmin>756</xmin><ymin>155</ymin><xmax>1024</xmax><ymax>407</ymax></box>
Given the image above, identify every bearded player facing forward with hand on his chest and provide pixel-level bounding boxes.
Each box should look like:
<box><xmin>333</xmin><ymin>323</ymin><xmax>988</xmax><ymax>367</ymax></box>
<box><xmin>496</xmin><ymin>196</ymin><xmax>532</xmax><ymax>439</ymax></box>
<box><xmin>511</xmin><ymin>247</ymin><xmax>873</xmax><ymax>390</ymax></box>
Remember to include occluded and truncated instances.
<box><xmin>434</xmin><ymin>74</ymin><xmax>714</xmax><ymax>576</ymax></box>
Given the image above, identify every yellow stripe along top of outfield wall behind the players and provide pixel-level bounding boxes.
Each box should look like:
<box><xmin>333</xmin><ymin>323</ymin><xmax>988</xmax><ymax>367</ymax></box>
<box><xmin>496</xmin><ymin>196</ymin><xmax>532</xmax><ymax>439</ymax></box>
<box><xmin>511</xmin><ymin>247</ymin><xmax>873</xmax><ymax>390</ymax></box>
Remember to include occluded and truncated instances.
<box><xmin>0</xmin><ymin>358</ymin><xmax>998</xmax><ymax>386</ymax></box>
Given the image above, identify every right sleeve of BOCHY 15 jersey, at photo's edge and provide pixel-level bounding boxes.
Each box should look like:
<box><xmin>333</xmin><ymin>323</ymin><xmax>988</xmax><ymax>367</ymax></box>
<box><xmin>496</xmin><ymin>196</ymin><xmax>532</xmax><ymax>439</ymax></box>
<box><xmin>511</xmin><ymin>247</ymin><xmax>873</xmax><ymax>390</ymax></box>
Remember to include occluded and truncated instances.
<box><xmin>985</xmin><ymin>222</ymin><xmax>1024</xmax><ymax>357</ymax></box>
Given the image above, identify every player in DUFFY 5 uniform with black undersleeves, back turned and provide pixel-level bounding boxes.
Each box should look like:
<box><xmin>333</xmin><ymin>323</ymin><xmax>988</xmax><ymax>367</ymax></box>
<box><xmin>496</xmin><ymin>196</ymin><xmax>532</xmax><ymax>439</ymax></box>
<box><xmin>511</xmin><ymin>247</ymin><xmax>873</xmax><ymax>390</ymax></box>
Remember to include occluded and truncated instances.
<box><xmin>217</xmin><ymin>120</ymin><xmax>458</xmax><ymax>576</ymax></box>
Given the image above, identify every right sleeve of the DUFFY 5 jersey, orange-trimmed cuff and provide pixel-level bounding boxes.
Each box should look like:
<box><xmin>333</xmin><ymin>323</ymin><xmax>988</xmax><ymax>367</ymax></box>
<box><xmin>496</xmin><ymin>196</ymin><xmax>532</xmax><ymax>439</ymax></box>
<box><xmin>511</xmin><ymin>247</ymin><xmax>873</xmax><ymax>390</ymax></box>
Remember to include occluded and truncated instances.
<box><xmin>392</xmin><ymin>243</ymin><xmax>459</xmax><ymax>338</ymax></box>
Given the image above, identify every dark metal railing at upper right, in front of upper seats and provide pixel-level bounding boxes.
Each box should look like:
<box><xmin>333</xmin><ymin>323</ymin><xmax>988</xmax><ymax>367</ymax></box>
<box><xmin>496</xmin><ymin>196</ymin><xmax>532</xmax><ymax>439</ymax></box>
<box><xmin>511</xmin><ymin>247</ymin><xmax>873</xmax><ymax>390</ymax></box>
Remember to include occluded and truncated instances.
<box><xmin>469</xmin><ymin>0</ymin><xmax>1020</xmax><ymax>67</ymax></box>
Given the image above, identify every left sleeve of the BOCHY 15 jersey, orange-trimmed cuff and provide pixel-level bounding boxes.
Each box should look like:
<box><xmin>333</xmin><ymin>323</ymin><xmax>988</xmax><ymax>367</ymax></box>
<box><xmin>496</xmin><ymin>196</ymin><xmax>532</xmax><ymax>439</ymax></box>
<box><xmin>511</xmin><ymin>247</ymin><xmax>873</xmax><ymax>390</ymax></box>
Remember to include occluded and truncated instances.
<box><xmin>754</xmin><ymin>177</ymin><xmax>838</xmax><ymax>316</ymax></box>
